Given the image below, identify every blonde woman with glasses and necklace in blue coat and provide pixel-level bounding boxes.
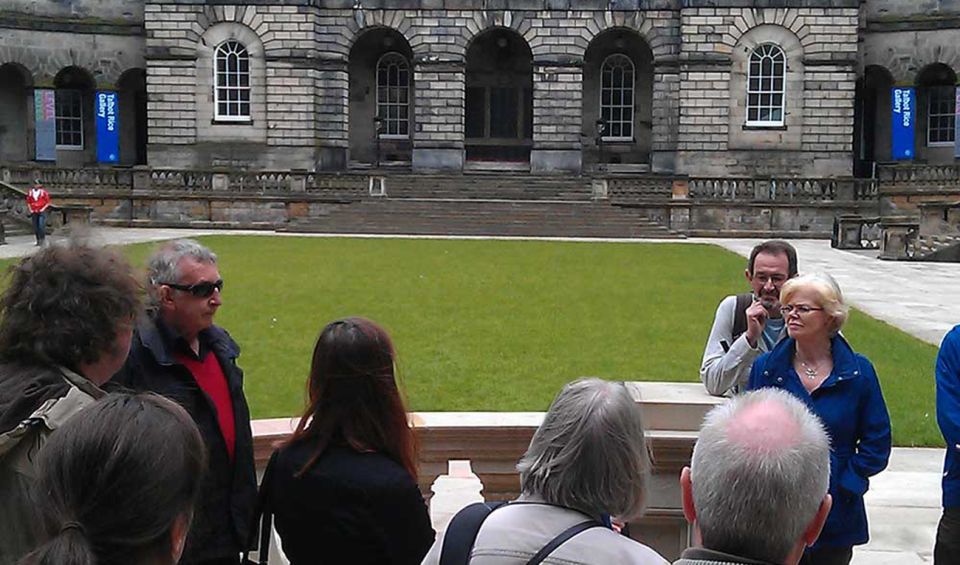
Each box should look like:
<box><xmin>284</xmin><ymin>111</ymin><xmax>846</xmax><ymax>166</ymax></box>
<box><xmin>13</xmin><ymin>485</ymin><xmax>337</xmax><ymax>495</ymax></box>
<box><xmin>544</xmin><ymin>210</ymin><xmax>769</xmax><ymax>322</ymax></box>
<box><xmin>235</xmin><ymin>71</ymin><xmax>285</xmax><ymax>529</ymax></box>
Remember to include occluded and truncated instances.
<box><xmin>748</xmin><ymin>274</ymin><xmax>890</xmax><ymax>565</ymax></box>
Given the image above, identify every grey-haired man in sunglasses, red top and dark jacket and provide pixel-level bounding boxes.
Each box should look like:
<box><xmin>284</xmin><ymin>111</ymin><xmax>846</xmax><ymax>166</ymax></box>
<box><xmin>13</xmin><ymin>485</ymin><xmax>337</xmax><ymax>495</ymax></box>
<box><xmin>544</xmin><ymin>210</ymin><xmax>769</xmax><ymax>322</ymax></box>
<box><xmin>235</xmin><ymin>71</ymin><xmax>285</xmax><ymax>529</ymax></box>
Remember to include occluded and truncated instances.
<box><xmin>114</xmin><ymin>239</ymin><xmax>257</xmax><ymax>565</ymax></box>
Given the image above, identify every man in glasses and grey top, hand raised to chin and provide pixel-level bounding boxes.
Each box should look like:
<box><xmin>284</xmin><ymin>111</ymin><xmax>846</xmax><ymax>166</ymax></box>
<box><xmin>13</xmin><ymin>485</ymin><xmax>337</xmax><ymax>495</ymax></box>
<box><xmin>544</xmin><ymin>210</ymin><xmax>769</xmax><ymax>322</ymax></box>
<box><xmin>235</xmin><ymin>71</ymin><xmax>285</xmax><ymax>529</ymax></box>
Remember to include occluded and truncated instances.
<box><xmin>700</xmin><ymin>240</ymin><xmax>797</xmax><ymax>396</ymax></box>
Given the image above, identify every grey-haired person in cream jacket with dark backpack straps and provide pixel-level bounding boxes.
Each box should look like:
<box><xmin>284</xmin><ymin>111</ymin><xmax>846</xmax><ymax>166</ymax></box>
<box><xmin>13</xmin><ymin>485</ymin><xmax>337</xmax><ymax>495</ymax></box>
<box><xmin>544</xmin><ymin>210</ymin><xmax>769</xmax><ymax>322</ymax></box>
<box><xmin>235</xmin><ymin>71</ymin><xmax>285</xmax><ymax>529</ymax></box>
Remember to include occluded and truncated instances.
<box><xmin>423</xmin><ymin>379</ymin><xmax>667</xmax><ymax>565</ymax></box>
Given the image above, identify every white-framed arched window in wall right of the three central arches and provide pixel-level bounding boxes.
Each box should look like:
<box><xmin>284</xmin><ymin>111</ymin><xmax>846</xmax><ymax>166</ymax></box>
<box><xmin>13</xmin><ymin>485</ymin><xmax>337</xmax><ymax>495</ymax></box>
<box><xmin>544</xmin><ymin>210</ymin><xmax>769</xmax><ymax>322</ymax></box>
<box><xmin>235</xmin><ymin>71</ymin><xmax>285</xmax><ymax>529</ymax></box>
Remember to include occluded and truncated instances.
<box><xmin>747</xmin><ymin>45</ymin><xmax>787</xmax><ymax>126</ymax></box>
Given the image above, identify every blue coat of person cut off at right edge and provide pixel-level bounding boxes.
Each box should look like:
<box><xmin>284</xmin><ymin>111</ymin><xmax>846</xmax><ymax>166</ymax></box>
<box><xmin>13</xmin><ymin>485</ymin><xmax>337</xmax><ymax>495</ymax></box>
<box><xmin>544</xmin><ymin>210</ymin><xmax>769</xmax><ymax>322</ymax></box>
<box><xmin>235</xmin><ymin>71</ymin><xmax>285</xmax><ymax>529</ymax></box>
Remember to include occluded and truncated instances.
<box><xmin>937</xmin><ymin>326</ymin><xmax>960</xmax><ymax>508</ymax></box>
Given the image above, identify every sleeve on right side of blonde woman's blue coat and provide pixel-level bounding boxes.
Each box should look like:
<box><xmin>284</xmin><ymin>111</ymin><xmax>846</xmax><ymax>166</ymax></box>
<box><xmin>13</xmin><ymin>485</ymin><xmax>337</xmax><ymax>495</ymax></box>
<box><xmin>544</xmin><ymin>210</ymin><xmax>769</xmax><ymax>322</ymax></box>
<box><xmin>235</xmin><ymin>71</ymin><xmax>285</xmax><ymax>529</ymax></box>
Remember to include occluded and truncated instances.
<box><xmin>839</xmin><ymin>356</ymin><xmax>891</xmax><ymax>496</ymax></box>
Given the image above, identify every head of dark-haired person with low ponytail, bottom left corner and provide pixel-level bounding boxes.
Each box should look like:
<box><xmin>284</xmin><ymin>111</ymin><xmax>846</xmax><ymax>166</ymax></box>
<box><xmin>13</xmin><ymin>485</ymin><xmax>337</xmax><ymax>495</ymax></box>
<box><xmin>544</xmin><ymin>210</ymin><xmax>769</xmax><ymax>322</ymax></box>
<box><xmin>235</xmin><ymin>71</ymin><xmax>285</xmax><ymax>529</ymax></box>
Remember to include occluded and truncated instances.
<box><xmin>22</xmin><ymin>393</ymin><xmax>206</xmax><ymax>565</ymax></box>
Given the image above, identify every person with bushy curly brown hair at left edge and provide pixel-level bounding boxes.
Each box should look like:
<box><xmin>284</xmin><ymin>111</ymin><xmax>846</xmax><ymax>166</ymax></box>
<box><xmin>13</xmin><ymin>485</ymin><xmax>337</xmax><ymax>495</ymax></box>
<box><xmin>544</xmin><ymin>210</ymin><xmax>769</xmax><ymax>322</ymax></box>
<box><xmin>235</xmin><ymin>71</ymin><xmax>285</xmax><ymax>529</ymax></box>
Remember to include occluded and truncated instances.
<box><xmin>0</xmin><ymin>243</ymin><xmax>141</xmax><ymax>565</ymax></box>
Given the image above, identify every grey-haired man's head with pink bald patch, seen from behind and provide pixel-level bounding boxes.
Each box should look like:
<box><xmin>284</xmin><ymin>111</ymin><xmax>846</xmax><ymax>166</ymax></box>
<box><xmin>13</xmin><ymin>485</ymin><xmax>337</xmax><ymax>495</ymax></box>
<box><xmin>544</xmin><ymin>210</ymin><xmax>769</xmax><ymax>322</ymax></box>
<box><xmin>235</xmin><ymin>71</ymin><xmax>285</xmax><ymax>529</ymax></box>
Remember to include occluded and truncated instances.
<box><xmin>690</xmin><ymin>388</ymin><xmax>830</xmax><ymax>563</ymax></box>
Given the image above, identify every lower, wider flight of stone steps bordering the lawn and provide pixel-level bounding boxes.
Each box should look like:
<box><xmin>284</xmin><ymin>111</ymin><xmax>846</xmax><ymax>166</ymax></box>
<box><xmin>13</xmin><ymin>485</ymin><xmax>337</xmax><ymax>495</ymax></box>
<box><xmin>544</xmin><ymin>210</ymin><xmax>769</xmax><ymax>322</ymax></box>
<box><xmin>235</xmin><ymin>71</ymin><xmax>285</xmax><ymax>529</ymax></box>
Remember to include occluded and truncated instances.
<box><xmin>285</xmin><ymin>196</ymin><xmax>681</xmax><ymax>238</ymax></box>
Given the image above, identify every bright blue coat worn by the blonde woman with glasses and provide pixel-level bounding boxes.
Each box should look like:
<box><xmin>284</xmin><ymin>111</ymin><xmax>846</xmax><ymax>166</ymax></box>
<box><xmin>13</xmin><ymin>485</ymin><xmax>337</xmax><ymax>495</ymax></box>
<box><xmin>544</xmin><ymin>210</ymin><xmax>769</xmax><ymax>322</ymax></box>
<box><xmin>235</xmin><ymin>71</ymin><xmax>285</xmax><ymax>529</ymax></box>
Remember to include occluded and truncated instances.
<box><xmin>748</xmin><ymin>336</ymin><xmax>890</xmax><ymax>547</ymax></box>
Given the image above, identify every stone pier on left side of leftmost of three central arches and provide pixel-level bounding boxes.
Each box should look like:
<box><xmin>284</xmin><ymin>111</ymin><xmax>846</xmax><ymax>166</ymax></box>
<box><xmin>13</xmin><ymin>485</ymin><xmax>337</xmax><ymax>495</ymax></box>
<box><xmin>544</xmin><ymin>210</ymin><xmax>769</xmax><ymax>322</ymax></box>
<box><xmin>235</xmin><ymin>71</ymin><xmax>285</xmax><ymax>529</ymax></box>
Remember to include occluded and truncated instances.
<box><xmin>314</xmin><ymin>58</ymin><xmax>350</xmax><ymax>171</ymax></box>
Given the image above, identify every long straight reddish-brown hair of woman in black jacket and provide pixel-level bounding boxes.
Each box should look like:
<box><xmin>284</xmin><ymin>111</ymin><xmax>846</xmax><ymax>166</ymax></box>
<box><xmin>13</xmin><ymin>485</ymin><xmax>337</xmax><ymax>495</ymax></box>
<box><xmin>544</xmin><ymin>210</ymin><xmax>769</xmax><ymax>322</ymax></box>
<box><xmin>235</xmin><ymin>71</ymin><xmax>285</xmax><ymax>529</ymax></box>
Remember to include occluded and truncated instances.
<box><xmin>287</xmin><ymin>318</ymin><xmax>417</xmax><ymax>480</ymax></box>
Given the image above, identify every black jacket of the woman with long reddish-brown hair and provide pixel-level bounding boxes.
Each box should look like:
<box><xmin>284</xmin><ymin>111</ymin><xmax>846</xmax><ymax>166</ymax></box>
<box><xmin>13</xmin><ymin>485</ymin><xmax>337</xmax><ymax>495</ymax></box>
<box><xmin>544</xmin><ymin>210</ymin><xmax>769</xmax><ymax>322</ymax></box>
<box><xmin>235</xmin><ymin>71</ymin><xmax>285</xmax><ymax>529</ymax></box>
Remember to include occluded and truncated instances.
<box><xmin>263</xmin><ymin>441</ymin><xmax>435</xmax><ymax>565</ymax></box>
